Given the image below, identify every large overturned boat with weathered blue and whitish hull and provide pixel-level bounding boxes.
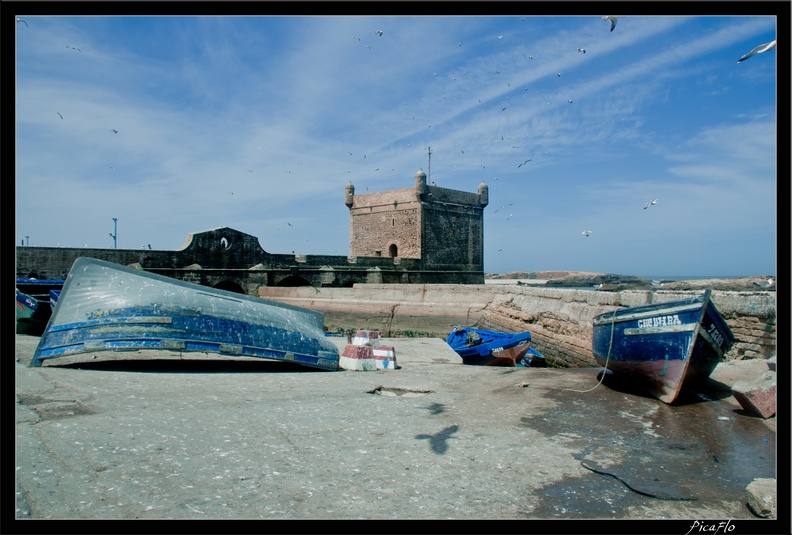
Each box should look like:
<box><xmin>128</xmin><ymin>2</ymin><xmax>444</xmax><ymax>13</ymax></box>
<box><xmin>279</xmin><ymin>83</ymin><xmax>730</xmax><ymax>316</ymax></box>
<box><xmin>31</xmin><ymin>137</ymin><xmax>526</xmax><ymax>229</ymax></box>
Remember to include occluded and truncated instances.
<box><xmin>31</xmin><ymin>258</ymin><xmax>339</xmax><ymax>370</ymax></box>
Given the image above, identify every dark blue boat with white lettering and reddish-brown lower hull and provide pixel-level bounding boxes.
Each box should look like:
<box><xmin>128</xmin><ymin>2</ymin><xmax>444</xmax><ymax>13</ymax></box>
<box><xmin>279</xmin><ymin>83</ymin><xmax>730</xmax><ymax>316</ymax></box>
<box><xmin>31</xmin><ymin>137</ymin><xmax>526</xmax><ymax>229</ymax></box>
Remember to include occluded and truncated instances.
<box><xmin>592</xmin><ymin>290</ymin><xmax>734</xmax><ymax>404</ymax></box>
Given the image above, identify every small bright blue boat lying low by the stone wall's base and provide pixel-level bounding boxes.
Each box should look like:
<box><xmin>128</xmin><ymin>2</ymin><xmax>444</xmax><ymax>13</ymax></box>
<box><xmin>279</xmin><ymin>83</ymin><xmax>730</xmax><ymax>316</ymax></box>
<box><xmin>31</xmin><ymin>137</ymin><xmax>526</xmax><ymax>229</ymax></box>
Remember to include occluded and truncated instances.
<box><xmin>446</xmin><ymin>325</ymin><xmax>544</xmax><ymax>366</ymax></box>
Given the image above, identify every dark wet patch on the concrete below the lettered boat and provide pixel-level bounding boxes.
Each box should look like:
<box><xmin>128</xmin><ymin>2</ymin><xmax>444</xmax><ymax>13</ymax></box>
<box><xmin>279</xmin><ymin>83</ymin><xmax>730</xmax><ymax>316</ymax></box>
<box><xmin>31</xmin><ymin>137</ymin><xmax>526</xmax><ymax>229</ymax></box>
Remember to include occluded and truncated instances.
<box><xmin>520</xmin><ymin>376</ymin><xmax>776</xmax><ymax>518</ymax></box>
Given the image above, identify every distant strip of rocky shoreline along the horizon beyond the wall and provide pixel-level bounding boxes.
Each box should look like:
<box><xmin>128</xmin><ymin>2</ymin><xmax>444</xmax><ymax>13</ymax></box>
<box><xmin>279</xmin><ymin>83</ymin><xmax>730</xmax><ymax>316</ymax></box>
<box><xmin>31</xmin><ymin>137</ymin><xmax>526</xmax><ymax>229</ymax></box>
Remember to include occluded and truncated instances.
<box><xmin>485</xmin><ymin>271</ymin><xmax>776</xmax><ymax>292</ymax></box>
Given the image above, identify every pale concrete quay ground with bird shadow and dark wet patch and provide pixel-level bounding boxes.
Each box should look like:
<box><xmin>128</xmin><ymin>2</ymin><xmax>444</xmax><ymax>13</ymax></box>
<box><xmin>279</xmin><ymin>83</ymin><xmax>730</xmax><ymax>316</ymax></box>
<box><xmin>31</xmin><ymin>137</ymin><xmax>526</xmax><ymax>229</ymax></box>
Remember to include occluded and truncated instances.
<box><xmin>12</xmin><ymin>335</ymin><xmax>780</xmax><ymax>533</ymax></box>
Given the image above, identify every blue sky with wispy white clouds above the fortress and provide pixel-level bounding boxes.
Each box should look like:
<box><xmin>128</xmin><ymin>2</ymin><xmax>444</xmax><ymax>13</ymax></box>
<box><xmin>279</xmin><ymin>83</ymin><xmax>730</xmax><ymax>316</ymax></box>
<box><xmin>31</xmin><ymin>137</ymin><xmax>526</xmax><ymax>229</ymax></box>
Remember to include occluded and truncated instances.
<box><xmin>13</xmin><ymin>3</ymin><xmax>789</xmax><ymax>276</ymax></box>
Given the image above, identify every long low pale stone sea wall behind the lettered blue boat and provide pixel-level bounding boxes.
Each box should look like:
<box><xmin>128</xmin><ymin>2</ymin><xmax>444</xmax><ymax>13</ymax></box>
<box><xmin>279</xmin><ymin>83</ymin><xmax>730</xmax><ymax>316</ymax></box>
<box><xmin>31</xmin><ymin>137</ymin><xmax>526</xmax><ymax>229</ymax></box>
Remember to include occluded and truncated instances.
<box><xmin>259</xmin><ymin>284</ymin><xmax>776</xmax><ymax>367</ymax></box>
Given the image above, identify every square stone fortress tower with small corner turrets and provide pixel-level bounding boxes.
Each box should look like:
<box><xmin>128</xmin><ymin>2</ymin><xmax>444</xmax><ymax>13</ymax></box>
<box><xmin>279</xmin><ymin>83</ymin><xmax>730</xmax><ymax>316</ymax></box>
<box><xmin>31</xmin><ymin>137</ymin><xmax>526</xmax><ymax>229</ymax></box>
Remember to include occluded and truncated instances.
<box><xmin>345</xmin><ymin>170</ymin><xmax>489</xmax><ymax>273</ymax></box>
